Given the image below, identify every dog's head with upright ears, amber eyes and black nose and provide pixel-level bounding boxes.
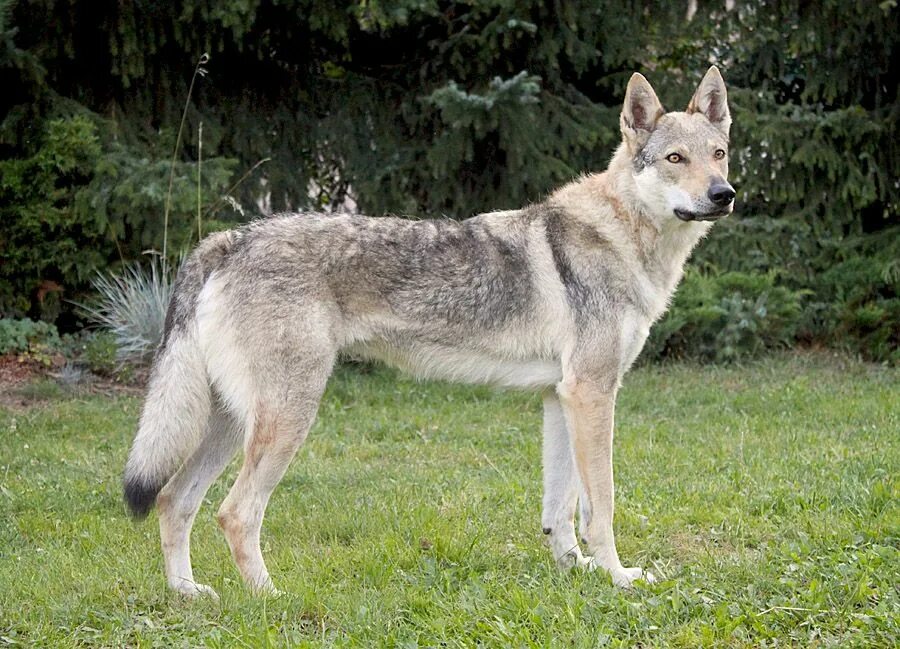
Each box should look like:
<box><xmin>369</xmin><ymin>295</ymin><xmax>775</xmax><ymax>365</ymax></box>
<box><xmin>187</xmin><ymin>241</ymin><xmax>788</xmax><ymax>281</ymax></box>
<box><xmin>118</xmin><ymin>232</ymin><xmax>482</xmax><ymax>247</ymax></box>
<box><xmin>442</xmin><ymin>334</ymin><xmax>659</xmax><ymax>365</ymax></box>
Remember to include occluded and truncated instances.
<box><xmin>619</xmin><ymin>66</ymin><xmax>735</xmax><ymax>221</ymax></box>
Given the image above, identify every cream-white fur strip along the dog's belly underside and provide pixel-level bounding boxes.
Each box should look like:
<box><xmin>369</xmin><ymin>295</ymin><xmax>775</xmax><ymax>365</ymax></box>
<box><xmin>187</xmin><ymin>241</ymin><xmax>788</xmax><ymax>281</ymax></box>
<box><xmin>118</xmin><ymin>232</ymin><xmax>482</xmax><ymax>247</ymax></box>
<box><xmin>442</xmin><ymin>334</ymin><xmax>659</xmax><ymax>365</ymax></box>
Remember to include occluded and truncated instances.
<box><xmin>345</xmin><ymin>343</ymin><xmax>562</xmax><ymax>389</ymax></box>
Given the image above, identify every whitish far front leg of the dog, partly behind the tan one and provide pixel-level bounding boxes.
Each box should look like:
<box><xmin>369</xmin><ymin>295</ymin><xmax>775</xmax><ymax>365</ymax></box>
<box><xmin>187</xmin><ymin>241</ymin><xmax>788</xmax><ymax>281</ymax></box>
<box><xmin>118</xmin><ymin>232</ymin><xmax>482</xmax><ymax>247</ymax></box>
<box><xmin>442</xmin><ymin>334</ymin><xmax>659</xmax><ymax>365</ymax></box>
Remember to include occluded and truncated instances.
<box><xmin>541</xmin><ymin>390</ymin><xmax>589</xmax><ymax>568</ymax></box>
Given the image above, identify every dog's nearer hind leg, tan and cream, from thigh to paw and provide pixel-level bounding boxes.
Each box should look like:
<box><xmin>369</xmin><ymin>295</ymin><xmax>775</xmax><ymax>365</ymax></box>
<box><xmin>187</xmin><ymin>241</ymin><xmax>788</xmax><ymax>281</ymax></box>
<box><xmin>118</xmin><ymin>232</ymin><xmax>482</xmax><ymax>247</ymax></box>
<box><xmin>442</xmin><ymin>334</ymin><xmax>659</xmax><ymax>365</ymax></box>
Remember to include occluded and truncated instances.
<box><xmin>218</xmin><ymin>358</ymin><xmax>334</xmax><ymax>592</ymax></box>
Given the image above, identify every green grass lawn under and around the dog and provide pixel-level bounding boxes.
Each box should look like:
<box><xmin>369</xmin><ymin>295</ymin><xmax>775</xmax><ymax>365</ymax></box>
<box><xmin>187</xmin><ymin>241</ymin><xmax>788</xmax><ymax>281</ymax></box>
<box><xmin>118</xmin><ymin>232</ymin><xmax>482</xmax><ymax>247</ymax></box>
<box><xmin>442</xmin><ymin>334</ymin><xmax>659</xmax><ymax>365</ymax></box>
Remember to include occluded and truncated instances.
<box><xmin>0</xmin><ymin>355</ymin><xmax>900</xmax><ymax>647</ymax></box>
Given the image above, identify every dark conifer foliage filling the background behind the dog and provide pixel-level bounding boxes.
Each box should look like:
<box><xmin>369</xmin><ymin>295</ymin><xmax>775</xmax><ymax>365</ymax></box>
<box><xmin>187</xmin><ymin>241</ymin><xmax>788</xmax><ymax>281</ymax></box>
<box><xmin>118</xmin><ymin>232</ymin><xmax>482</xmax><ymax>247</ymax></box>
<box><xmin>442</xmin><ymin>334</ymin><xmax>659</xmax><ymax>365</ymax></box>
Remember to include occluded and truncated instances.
<box><xmin>0</xmin><ymin>0</ymin><xmax>900</xmax><ymax>358</ymax></box>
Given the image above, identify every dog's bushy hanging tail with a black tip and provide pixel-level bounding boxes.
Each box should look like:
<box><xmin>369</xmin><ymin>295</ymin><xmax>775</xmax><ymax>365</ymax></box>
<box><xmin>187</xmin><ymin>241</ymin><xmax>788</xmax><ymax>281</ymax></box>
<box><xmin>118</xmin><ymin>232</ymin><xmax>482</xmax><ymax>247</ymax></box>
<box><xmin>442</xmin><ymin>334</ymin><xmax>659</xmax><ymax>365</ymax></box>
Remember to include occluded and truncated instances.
<box><xmin>124</xmin><ymin>233</ymin><xmax>232</xmax><ymax>518</ymax></box>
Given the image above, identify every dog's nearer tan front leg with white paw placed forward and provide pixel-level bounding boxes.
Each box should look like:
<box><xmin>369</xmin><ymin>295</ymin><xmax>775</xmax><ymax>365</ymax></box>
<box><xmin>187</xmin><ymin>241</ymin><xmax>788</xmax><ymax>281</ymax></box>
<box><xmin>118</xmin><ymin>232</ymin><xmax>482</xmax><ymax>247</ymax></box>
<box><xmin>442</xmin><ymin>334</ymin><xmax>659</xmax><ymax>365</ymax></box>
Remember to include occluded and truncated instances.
<box><xmin>557</xmin><ymin>378</ymin><xmax>653</xmax><ymax>586</ymax></box>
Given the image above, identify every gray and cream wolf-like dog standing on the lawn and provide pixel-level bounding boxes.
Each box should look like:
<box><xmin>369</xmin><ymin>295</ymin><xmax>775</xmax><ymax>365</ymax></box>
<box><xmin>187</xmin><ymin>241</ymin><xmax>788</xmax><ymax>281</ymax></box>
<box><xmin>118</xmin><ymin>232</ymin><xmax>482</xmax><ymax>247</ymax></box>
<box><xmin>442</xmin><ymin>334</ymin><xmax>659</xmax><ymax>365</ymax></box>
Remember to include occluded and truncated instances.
<box><xmin>124</xmin><ymin>67</ymin><xmax>735</xmax><ymax>597</ymax></box>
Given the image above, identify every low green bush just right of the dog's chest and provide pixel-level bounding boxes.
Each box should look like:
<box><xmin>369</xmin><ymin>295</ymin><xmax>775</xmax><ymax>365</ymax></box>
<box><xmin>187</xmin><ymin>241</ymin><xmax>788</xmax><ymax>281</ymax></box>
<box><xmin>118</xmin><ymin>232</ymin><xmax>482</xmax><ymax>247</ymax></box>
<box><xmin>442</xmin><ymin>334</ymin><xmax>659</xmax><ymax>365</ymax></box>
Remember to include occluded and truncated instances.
<box><xmin>643</xmin><ymin>271</ymin><xmax>807</xmax><ymax>362</ymax></box>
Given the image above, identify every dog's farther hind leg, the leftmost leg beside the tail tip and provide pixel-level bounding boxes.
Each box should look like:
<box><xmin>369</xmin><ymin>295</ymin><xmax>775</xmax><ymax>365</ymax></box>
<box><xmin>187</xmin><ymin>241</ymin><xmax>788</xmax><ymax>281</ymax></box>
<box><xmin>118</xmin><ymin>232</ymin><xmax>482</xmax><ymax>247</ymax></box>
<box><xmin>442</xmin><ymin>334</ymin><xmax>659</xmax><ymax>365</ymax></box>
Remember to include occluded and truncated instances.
<box><xmin>156</xmin><ymin>404</ymin><xmax>241</xmax><ymax>597</ymax></box>
